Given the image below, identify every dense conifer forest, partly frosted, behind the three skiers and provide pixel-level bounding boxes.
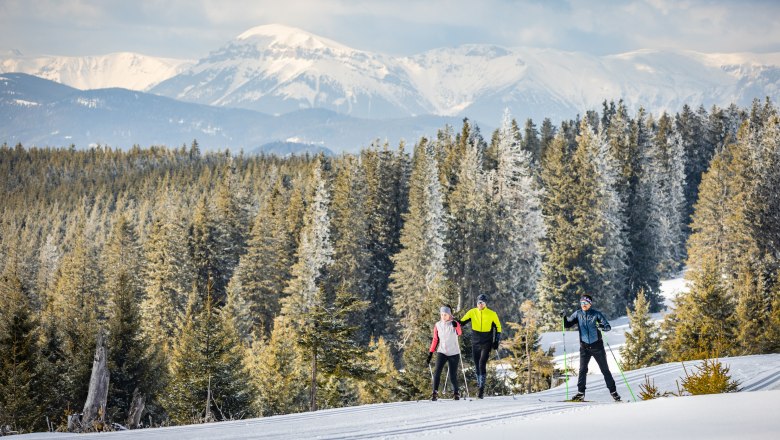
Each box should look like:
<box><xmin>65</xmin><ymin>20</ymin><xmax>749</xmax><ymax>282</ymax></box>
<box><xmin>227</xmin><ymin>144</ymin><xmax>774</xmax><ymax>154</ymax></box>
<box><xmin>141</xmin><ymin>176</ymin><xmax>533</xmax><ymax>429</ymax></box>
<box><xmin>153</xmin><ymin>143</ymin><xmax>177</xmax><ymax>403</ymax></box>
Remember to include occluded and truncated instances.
<box><xmin>0</xmin><ymin>100</ymin><xmax>780</xmax><ymax>432</ymax></box>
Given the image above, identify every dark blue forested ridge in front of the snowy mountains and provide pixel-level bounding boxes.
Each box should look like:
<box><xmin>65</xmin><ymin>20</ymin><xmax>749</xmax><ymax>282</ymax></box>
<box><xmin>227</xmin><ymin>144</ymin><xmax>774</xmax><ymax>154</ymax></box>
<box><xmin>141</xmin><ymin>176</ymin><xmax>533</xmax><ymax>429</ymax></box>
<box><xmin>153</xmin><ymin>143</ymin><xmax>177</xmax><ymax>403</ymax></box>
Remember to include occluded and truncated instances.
<box><xmin>0</xmin><ymin>73</ymin><xmax>458</xmax><ymax>156</ymax></box>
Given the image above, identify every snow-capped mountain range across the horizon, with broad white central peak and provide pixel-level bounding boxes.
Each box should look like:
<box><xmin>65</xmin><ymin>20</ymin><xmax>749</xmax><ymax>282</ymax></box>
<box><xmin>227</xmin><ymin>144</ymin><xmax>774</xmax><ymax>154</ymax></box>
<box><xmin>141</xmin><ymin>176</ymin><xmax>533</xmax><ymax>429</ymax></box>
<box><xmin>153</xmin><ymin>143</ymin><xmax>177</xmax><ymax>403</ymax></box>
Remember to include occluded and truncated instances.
<box><xmin>0</xmin><ymin>25</ymin><xmax>780</xmax><ymax>150</ymax></box>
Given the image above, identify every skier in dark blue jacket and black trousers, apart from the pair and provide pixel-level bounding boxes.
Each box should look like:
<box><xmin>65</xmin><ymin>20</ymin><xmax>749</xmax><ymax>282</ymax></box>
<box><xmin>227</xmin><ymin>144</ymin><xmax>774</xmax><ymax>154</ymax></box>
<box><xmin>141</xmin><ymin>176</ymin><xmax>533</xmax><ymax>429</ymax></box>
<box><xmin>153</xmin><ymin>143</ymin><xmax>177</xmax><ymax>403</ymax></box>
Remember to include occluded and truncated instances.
<box><xmin>563</xmin><ymin>295</ymin><xmax>620</xmax><ymax>402</ymax></box>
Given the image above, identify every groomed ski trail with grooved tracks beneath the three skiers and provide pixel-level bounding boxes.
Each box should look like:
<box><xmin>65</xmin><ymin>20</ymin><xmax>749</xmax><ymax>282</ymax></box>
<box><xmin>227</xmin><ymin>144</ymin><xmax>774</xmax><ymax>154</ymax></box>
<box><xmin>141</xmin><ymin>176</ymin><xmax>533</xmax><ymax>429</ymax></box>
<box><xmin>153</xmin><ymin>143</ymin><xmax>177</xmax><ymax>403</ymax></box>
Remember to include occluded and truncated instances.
<box><xmin>16</xmin><ymin>354</ymin><xmax>780</xmax><ymax>440</ymax></box>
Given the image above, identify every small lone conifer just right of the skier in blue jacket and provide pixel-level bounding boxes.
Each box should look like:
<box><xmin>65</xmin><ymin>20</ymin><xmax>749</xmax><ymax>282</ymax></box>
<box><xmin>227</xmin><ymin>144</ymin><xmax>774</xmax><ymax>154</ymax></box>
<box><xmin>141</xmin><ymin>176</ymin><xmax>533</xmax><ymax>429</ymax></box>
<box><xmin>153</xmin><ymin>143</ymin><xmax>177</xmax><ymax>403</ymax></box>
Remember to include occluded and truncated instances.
<box><xmin>620</xmin><ymin>290</ymin><xmax>662</xmax><ymax>370</ymax></box>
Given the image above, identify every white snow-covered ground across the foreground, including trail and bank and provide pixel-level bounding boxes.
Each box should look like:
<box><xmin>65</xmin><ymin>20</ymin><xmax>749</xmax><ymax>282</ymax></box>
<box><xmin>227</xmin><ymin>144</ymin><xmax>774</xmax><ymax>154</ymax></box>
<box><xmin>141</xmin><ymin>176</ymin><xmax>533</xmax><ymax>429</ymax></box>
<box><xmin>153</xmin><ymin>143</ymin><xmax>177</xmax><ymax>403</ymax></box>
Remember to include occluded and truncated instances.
<box><xmin>18</xmin><ymin>281</ymin><xmax>780</xmax><ymax>440</ymax></box>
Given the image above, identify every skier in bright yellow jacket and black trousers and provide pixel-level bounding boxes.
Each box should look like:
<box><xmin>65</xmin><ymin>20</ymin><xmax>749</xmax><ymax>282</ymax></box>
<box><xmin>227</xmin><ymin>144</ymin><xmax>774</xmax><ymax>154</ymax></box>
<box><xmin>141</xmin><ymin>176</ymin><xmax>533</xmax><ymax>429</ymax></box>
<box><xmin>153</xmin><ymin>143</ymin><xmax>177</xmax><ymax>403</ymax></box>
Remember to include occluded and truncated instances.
<box><xmin>460</xmin><ymin>293</ymin><xmax>501</xmax><ymax>399</ymax></box>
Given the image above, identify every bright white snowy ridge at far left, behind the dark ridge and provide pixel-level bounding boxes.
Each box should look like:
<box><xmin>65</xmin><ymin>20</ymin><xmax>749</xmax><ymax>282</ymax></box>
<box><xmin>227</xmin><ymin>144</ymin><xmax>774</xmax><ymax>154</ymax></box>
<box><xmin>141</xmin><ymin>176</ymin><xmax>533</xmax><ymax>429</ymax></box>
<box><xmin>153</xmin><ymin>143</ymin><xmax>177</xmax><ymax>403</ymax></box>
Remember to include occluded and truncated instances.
<box><xmin>0</xmin><ymin>52</ymin><xmax>192</xmax><ymax>90</ymax></box>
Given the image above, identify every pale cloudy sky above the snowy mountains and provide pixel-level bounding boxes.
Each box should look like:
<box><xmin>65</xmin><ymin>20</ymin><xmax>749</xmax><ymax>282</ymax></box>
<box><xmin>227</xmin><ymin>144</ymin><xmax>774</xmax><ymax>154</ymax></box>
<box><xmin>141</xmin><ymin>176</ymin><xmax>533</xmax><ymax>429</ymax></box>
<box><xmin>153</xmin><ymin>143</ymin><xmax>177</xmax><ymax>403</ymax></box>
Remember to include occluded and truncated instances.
<box><xmin>0</xmin><ymin>0</ymin><xmax>780</xmax><ymax>59</ymax></box>
